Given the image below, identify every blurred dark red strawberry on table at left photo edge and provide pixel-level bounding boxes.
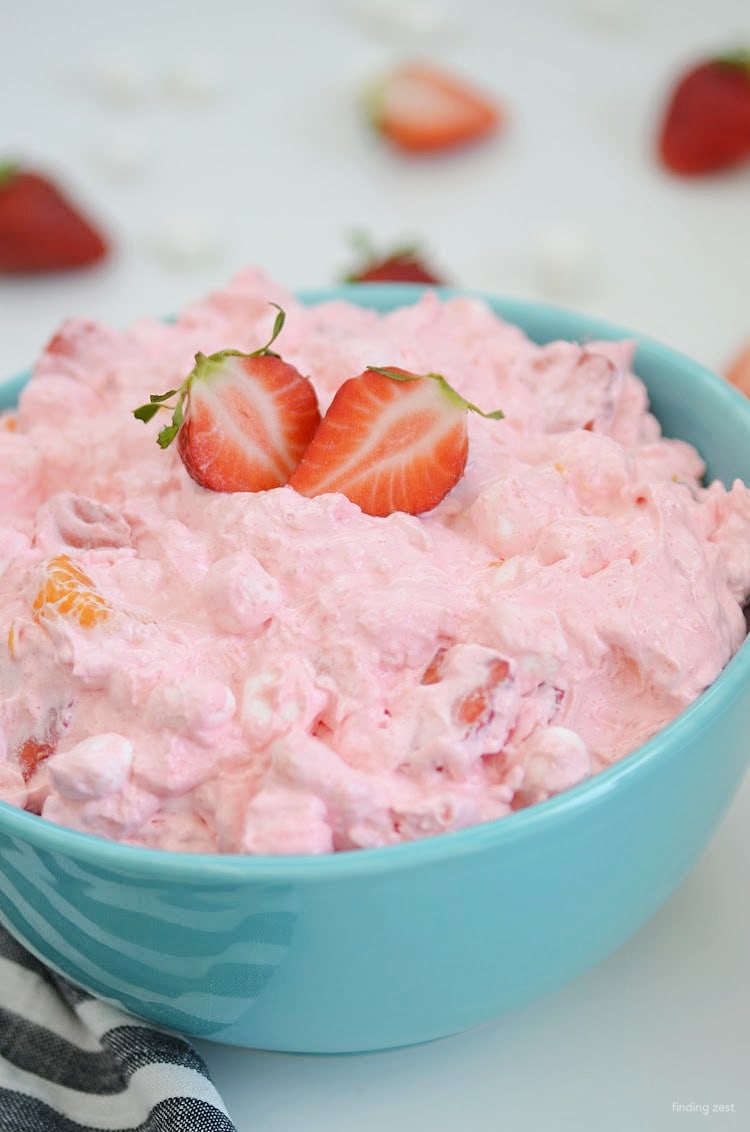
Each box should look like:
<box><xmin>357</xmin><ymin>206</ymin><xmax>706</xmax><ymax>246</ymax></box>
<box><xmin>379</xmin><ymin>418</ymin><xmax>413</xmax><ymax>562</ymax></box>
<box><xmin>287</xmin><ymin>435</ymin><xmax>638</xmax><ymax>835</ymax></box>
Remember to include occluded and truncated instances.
<box><xmin>0</xmin><ymin>164</ymin><xmax>109</xmax><ymax>275</ymax></box>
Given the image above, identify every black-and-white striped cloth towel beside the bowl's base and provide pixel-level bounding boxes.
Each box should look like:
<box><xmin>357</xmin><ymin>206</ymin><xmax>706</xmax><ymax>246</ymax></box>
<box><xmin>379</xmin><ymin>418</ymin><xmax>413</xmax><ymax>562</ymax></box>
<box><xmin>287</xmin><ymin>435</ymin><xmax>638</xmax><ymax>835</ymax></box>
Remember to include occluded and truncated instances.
<box><xmin>0</xmin><ymin>927</ymin><xmax>235</xmax><ymax>1132</ymax></box>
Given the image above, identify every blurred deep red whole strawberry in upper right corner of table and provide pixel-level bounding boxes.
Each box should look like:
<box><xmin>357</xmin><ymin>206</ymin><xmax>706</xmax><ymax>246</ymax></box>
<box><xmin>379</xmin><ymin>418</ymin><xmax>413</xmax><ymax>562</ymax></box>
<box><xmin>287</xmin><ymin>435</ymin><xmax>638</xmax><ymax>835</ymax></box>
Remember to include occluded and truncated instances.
<box><xmin>658</xmin><ymin>49</ymin><xmax>750</xmax><ymax>177</ymax></box>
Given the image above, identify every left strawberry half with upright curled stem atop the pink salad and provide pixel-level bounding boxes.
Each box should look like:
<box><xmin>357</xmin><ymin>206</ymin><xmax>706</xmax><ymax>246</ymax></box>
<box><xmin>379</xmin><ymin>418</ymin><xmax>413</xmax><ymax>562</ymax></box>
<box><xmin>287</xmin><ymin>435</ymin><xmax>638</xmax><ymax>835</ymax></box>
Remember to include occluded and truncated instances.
<box><xmin>133</xmin><ymin>303</ymin><xmax>320</xmax><ymax>491</ymax></box>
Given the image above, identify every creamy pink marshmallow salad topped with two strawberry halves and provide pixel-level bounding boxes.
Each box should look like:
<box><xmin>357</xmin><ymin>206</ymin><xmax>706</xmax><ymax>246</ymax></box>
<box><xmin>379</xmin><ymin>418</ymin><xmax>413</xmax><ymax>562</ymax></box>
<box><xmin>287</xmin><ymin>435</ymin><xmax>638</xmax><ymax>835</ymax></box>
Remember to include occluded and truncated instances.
<box><xmin>0</xmin><ymin>268</ymin><xmax>750</xmax><ymax>855</ymax></box>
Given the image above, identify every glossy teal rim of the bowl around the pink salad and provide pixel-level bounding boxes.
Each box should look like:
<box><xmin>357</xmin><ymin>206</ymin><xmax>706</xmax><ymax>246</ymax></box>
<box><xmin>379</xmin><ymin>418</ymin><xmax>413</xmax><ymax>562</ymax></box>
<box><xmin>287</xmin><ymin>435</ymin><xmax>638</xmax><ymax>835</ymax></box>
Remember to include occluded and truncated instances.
<box><xmin>0</xmin><ymin>283</ymin><xmax>750</xmax><ymax>885</ymax></box>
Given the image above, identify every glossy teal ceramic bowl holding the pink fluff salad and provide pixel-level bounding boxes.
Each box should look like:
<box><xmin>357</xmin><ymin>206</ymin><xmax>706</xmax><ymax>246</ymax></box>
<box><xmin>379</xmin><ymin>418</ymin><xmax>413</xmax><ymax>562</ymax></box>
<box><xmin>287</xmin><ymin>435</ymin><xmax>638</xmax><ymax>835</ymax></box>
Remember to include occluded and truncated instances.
<box><xmin>0</xmin><ymin>284</ymin><xmax>750</xmax><ymax>1053</ymax></box>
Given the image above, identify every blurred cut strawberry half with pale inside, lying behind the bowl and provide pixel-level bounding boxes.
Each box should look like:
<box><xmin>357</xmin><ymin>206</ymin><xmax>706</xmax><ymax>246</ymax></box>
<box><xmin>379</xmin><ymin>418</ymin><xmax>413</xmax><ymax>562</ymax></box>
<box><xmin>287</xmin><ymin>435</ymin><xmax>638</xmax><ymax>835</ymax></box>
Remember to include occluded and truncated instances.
<box><xmin>368</xmin><ymin>62</ymin><xmax>505</xmax><ymax>153</ymax></box>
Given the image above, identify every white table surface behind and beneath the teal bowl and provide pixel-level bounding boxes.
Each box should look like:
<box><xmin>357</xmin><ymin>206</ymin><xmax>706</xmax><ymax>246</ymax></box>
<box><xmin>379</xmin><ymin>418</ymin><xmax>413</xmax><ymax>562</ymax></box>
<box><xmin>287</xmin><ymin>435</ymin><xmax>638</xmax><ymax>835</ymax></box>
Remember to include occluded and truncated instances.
<box><xmin>0</xmin><ymin>0</ymin><xmax>750</xmax><ymax>1132</ymax></box>
